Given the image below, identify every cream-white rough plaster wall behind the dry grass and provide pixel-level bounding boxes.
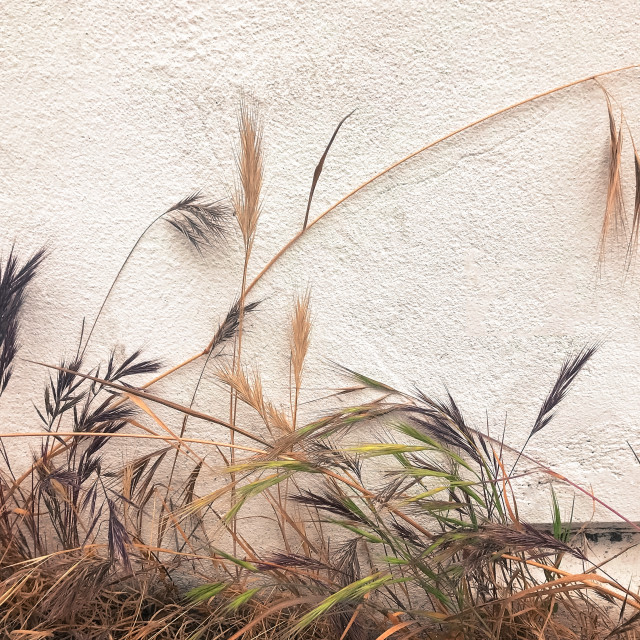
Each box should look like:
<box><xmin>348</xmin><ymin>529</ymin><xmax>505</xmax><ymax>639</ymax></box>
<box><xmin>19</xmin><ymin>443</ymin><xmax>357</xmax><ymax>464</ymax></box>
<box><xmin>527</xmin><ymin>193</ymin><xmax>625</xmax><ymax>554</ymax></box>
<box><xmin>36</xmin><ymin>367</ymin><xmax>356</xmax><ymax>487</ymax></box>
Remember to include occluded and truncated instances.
<box><xmin>0</xmin><ymin>0</ymin><xmax>640</xmax><ymax>544</ymax></box>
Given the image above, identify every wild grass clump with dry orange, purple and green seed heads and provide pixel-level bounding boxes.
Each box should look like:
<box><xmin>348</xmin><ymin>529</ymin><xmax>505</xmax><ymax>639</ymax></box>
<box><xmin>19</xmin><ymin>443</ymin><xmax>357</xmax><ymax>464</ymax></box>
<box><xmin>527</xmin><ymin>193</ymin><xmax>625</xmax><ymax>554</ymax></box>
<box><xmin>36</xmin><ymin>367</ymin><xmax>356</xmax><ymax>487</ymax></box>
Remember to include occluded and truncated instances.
<box><xmin>0</xmin><ymin>67</ymin><xmax>640</xmax><ymax>640</ymax></box>
